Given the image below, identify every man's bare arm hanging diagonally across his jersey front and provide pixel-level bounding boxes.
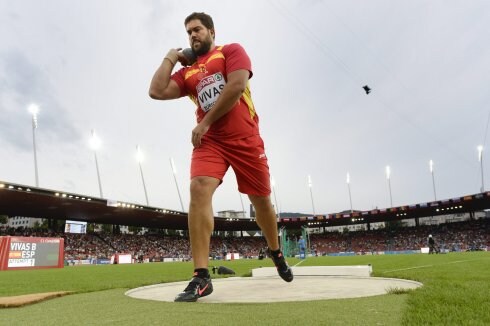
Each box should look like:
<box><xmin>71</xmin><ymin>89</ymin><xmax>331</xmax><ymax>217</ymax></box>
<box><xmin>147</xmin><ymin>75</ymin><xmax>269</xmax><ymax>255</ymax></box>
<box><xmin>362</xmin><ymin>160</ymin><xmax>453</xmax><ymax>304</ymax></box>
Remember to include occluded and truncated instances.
<box><xmin>192</xmin><ymin>69</ymin><xmax>250</xmax><ymax>147</ymax></box>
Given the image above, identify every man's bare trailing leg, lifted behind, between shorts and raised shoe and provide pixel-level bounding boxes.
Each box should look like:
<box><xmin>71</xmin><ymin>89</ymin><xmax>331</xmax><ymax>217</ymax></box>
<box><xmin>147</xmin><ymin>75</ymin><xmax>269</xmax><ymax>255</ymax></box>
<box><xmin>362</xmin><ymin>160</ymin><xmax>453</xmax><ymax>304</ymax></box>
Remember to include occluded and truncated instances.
<box><xmin>248</xmin><ymin>195</ymin><xmax>279</xmax><ymax>250</ymax></box>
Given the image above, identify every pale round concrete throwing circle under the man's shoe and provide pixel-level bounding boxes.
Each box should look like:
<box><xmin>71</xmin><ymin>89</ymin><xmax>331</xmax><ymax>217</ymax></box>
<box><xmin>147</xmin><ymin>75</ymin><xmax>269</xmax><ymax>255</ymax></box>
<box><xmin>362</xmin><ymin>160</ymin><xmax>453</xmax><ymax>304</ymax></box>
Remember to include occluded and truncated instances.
<box><xmin>125</xmin><ymin>276</ymin><xmax>422</xmax><ymax>303</ymax></box>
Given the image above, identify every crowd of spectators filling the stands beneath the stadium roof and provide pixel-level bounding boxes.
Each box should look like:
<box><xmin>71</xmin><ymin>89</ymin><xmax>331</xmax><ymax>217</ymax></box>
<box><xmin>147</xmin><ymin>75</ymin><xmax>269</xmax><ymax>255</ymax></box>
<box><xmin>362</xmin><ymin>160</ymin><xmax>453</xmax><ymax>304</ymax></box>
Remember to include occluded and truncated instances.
<box><xmin>0</xmin><ymin>219</ymin><xmax>490</xmax><ymax>261</ymax></box>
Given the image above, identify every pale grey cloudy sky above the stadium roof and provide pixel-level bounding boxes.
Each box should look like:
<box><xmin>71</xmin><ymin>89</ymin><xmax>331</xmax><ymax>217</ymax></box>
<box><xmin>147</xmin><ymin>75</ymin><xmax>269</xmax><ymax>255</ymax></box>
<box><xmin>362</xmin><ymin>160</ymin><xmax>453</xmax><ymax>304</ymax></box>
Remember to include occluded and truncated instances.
<box><xmin>0</xmin><ymin>0</ymin><xmax>490</xmax><ymax>214</ymax></box>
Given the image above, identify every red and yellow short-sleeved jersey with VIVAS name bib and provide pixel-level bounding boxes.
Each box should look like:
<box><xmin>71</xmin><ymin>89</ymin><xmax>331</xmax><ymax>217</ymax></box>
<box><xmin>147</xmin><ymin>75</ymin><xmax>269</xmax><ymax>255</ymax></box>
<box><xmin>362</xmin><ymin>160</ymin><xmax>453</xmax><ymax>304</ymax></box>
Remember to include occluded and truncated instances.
<box><xmin>171</xmin><ymin>43</ymin><xmax>259</xmax><ymax>139</ymax></box>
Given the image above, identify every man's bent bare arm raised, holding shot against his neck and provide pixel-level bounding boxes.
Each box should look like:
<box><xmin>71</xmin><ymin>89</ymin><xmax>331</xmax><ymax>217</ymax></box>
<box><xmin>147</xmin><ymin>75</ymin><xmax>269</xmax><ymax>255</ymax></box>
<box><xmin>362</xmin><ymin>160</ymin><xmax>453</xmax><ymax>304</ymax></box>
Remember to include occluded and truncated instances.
<box><xmin>149</xmin><ymin>49</ymin><xmax>180</xmax><ymax>100</ymax></box>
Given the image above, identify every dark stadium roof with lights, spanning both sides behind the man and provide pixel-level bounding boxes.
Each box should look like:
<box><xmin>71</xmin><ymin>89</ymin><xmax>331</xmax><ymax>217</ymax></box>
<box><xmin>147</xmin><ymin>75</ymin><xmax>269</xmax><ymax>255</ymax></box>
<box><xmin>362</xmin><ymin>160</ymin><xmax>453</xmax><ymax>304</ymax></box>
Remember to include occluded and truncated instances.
<box><xmin>0</xmin><ymin>181</ymin><xmax>490</xmax><ymax>231</ymax></box>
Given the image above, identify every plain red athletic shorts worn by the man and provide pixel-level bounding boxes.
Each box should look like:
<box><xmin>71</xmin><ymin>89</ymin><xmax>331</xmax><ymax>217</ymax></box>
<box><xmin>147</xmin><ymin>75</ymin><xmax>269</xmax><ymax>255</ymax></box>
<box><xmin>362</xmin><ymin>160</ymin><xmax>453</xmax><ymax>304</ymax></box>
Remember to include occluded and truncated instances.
<box><xmin>191</xmin><ymin>135</ymin><xmax>271</xmax><ymax>196</ymax></box>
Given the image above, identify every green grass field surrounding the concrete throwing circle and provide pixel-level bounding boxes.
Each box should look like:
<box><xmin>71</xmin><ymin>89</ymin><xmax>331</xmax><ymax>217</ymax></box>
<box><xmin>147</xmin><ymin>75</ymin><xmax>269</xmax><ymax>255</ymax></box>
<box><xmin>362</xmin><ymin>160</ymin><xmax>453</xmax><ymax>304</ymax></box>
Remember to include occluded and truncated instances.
<box><xmin>0</xmin><ymin>252</ymin><xmax>490</xmax><ymax>326</ymax></box>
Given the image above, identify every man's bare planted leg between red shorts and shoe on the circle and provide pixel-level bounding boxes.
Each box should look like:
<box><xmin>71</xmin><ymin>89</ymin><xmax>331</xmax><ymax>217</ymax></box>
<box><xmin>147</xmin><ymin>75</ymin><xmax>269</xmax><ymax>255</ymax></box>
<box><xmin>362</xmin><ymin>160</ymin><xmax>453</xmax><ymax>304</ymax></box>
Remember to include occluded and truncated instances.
<box><xmin>188</xmin><ymin>176</ymin><xmax>220</xmax><ymax>269</ymax></box>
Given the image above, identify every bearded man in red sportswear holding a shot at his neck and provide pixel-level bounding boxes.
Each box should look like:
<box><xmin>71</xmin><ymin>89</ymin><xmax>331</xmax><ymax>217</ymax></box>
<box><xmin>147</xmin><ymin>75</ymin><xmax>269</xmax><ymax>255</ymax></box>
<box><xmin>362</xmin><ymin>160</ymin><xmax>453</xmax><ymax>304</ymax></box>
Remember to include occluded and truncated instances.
<box><xmin>150</xmin><ymin>13</ymin><xmax>293</xmax><ymax>302</ymax></box>
